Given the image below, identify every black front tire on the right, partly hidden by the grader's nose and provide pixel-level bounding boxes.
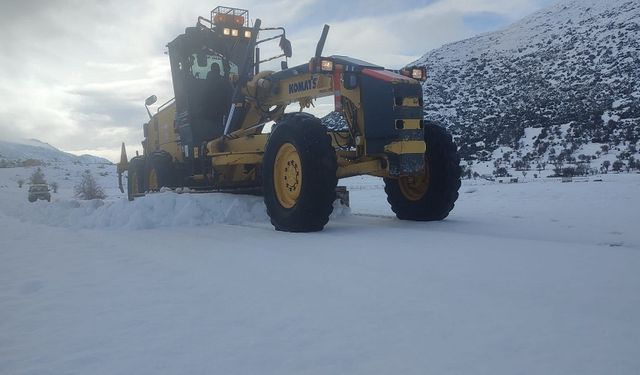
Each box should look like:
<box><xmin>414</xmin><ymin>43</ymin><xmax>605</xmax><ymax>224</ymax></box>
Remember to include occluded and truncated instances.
<box><xmin>384</xmin><ymin>122</ymin><xmax>461</xmax><ymax>221</ymax></box>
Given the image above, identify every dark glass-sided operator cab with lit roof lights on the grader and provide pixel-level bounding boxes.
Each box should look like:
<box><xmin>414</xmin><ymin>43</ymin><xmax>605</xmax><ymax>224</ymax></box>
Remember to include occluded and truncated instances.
<box><xmin>167</xmin><ymin>7</ymin><xmax>253</xmax><ymax>151</ymax></box>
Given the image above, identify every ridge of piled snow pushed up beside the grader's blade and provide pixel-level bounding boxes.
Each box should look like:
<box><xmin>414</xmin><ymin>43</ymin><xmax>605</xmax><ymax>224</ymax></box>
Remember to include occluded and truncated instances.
<box><xmin>3</xmin><ymin>191</ymin><xmax>350</xmax><ymax>230</ymax></box>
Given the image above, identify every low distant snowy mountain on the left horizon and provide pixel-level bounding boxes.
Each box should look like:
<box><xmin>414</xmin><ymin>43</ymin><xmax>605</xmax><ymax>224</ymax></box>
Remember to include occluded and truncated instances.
<box><xmin>0</xmin><ymin>139</ymin><xmax>112</xmax><ymax>164</ymax></box>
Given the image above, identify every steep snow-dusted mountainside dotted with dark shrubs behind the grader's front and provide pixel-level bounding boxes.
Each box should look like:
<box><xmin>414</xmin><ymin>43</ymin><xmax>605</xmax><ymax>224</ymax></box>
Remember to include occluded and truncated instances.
<box><xmin>415</xmin><ymin>0</ymin><xmax>640</xmax><ymax>175</ymax></box>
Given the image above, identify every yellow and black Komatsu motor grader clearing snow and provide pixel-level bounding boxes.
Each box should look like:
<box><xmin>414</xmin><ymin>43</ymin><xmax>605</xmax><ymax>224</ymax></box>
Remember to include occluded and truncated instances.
<box><xmin>117</xmin><ymin>7</ymin><xmax>460</xmax><ymax>232</ymax></box>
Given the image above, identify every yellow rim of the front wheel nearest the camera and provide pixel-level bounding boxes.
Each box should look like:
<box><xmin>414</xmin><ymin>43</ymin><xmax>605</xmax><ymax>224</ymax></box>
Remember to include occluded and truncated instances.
<box><xmin>273</xmin><ymin>143</ymin><xmax>302</xmax><ymax>208</ymax></box>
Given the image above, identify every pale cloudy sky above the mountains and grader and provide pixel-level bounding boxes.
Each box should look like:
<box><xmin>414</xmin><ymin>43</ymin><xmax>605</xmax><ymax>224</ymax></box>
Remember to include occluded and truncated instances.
<box><xmin>0</xmin><ymin>0</ymin><xmax>554</xmax><ymax>161</ymax></box>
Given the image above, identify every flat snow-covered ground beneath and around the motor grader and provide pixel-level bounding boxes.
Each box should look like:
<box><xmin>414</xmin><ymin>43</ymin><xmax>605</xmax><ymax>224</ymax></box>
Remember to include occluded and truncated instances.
<box><xmin>0</xmin><ymin>165</ymin><xmax>640</xmax><ymax>375</ymax></box>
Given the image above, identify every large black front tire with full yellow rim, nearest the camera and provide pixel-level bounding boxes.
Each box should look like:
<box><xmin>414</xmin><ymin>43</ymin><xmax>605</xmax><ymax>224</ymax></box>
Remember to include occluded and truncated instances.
<box><xmin>262</xmin><ymin>113</ymin><xmax>338</xmax><ymax>232</ymax></box>
